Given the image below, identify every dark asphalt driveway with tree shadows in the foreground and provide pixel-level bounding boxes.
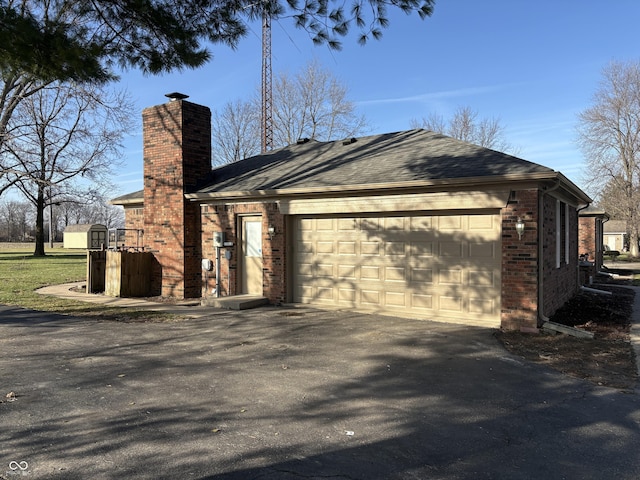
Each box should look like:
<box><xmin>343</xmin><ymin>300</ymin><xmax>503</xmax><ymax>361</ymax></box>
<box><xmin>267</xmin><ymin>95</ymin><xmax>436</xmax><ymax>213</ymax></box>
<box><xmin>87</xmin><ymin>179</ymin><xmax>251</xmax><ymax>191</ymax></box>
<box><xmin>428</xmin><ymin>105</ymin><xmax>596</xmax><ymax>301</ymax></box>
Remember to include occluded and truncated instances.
<box><xmin>0</xmin><ymin>307</ymin><xmax>640</xmax><ymax>480</ymax></box>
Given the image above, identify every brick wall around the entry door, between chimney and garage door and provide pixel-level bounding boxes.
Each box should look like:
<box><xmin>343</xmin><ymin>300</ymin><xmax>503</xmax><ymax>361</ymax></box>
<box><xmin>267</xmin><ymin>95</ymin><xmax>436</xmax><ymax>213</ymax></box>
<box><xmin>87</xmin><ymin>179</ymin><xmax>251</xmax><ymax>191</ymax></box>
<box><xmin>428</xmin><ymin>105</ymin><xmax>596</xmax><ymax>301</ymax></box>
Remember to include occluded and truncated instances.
<box><xmin>202</xmin><ymin>203</ymin><xmax>287</xmax><ymax>304</ymax></box>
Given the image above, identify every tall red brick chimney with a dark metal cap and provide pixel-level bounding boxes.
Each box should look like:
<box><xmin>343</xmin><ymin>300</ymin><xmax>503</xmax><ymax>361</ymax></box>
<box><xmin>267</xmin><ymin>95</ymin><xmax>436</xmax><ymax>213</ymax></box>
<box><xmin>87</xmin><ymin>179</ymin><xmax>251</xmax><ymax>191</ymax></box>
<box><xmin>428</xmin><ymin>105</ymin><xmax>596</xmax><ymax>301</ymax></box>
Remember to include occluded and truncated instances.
<box><xmin>142</xmin><ymin>93</ymin><xmax>211</xmax><ymax>298</ymax></box>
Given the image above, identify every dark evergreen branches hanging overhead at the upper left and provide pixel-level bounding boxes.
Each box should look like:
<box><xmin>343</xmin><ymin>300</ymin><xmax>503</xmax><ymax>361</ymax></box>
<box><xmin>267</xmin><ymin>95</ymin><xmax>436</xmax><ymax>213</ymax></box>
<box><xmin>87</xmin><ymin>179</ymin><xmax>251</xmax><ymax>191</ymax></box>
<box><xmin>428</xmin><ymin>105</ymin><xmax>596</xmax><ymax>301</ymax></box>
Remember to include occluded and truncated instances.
<box><xmin>0</xmin><ymin>0</ymin><xmax>435</xmax><ymax>82</ymax></box>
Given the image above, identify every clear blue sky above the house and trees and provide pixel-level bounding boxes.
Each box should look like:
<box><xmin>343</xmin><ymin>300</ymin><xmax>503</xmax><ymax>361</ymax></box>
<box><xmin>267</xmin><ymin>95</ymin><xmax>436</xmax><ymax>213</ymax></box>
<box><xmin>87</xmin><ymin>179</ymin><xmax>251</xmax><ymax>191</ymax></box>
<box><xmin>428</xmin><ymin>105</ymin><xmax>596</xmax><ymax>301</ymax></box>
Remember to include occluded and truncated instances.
<box><xmin>117</xmin><ymin>0</ymin><xmax>640</xmax><ymax>194</ymax></box>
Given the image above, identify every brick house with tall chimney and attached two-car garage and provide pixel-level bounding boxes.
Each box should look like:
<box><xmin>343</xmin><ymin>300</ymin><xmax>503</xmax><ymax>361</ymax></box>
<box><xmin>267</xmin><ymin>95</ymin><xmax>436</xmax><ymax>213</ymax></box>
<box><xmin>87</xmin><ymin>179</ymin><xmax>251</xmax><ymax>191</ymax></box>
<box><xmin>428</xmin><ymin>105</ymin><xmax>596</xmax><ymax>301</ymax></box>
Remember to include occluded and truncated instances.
<box><xmin>112</xmin><ymin>96</ymin><xmax>591</xmax><ymax>331</ymax></box>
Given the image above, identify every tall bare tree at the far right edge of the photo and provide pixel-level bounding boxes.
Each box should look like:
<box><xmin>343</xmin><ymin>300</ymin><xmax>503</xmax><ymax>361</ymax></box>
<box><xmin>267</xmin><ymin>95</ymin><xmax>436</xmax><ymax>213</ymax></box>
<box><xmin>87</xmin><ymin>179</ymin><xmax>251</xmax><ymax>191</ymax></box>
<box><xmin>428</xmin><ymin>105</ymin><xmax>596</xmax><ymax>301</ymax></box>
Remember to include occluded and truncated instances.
<box><xmin>578</xmin><ymin>62</ymin><xmax>640</xmax><ymax>256</ymax></box>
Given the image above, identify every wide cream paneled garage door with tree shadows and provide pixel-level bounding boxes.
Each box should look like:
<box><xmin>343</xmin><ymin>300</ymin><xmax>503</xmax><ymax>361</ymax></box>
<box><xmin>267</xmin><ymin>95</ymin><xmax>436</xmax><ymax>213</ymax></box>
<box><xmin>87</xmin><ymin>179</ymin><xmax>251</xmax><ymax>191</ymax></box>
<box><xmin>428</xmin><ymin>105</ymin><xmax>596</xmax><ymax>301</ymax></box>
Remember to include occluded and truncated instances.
<box><xmin>293</xmin><ymin>213</ymin><xmax>501</xmax><ymax>327</ymax></box>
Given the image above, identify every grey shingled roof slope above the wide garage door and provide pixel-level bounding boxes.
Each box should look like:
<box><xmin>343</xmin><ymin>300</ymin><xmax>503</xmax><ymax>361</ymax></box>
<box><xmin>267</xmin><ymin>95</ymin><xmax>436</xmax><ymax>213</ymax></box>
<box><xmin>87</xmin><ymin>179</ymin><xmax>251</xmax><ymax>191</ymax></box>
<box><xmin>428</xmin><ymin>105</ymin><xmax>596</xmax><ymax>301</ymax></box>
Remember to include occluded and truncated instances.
<box><xmin>198</xmin><ymin>129</ymin><xmax>554</xmax><ymax>194</ymax></box>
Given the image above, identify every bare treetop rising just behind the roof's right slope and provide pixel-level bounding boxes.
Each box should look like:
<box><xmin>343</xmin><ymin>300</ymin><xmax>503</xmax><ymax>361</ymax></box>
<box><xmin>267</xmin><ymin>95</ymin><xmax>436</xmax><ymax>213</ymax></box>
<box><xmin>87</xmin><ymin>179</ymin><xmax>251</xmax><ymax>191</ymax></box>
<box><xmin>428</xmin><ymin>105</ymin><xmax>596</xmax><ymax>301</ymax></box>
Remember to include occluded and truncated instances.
<box><xmin>411</xmin><ymin>107</ymin><xmax>517</xmax><ymax>154</ymax></box>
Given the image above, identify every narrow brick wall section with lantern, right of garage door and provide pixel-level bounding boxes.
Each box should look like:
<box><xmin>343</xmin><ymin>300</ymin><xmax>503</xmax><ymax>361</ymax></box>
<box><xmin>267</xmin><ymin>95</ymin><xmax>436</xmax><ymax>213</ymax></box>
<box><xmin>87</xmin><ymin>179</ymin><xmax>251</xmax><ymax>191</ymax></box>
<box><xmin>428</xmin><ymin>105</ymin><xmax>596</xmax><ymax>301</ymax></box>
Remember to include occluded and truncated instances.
<box><xmin>501</xmin><ymin>189</ymin><xmax>538</xmax><ymax>331</ymax></box>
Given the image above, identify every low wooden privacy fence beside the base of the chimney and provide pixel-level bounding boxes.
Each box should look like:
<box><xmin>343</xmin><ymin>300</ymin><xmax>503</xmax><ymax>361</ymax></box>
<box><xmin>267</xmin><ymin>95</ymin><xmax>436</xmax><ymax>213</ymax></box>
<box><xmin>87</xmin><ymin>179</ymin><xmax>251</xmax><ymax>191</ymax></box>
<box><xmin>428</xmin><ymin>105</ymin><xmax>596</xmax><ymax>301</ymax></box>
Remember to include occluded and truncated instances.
<box><xmin>87</xmin><ymin>250</ymin><xmax>153</xmax><ymax>297</ymax></box>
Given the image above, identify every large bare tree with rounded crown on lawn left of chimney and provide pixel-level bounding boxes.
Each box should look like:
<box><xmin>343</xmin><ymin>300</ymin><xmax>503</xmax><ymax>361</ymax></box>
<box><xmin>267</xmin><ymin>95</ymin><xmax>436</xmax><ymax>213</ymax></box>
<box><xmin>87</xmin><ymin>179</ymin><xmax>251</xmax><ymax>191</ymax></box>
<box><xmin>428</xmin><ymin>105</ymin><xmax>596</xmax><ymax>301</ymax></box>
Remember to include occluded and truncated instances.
<box><xmin>4</xmin><ymin>83</ymin><xmax>134</xmax><ymax>256</ymax></box>
